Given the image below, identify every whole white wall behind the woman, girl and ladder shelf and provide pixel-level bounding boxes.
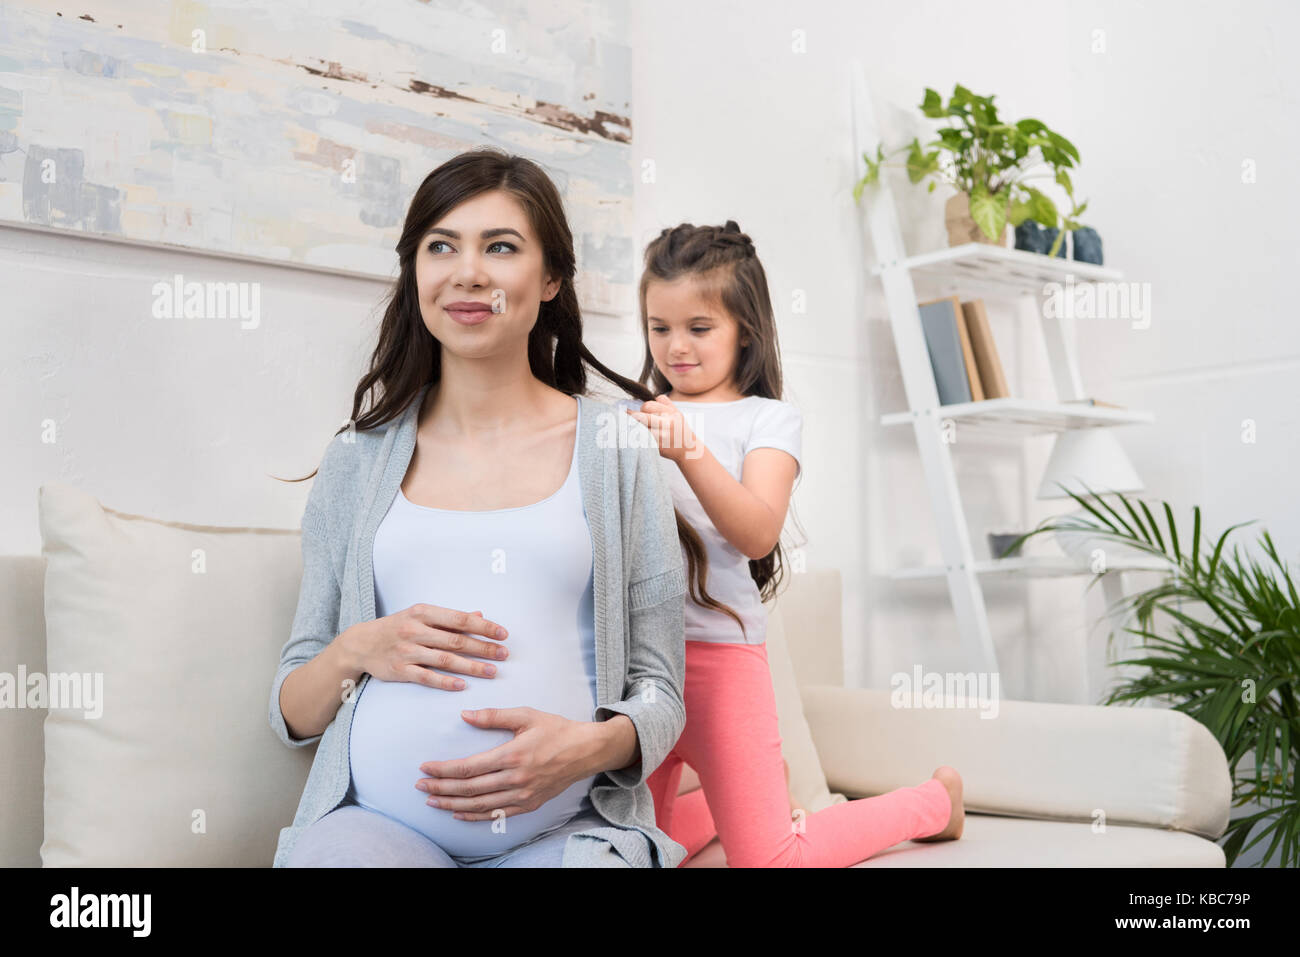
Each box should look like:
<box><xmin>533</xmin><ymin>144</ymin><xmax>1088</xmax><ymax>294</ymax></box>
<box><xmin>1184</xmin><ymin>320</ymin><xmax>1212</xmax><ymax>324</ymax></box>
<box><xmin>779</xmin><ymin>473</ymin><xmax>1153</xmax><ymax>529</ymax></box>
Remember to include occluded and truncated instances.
<box><xmin>0</xmin><ymin>0</ymin><xmax>1300</xmax><ymax>717</ymax></box>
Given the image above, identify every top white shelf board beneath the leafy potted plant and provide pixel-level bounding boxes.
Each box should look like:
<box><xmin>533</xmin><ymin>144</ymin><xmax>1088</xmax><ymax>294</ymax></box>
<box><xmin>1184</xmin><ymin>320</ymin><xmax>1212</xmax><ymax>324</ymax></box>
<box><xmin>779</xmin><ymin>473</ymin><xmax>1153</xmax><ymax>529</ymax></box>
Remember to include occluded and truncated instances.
<box><xmin>871</xmin><ymin>243</ymin><xmax>1123</xmax><ymax>293</ymax></box>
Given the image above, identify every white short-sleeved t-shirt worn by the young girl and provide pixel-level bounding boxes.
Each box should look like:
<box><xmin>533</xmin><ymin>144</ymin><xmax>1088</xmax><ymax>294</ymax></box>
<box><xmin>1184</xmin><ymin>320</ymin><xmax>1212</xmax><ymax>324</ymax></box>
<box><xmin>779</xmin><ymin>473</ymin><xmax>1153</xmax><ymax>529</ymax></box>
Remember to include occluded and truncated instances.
<box><xmin>618</xmin><ymin>395</ymin><xmax>803</xmax><ymax>645</ymax></box>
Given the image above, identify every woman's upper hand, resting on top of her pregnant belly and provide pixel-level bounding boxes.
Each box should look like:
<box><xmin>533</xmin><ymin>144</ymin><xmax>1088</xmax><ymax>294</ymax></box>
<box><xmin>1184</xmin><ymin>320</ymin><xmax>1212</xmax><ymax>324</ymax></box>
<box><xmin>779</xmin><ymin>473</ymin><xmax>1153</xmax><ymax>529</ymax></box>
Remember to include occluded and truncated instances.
<box><xmin>342</xmin><ymin>605</ymin><xmax>508</xmax><ymax>692</ymax></box>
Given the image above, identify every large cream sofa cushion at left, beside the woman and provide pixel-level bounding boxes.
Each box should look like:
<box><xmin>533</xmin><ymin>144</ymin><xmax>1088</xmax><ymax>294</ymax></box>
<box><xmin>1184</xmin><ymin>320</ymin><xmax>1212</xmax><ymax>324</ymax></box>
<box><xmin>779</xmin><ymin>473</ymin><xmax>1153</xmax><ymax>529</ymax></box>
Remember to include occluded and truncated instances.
<box><xmin>39</xmin><ymin>482</ymin><xmax>315</xmax><ymax>867</ymax></box>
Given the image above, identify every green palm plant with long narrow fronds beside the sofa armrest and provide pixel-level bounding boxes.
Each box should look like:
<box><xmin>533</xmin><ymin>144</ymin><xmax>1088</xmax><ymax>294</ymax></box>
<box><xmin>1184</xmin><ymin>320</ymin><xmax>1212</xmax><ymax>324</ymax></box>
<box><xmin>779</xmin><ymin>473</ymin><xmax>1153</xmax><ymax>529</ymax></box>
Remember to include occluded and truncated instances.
<box><xmin>1009</xmin><ymin>482</ymin><xmax>1300</xmax><ymax>867</ymax></box>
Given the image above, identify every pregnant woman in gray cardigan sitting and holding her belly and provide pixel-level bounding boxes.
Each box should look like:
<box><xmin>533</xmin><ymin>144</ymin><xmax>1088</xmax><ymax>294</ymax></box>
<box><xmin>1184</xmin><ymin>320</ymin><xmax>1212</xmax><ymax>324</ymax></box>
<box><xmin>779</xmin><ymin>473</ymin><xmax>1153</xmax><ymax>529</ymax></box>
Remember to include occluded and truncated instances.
<box><xmin>263</xmin><ymin>151</ymin><xmax>711</xmax><ymax>867</ymax></box>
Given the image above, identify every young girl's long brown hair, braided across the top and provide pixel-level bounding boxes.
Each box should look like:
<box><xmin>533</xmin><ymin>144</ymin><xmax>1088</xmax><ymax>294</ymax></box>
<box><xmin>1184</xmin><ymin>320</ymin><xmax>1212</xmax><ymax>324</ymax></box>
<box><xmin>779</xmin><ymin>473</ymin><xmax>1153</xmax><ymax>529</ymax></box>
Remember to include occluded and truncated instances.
<box><xmin>638</xmin><ymin>220</ymin><xmax>798</xmax><ymax>620</ymax></box>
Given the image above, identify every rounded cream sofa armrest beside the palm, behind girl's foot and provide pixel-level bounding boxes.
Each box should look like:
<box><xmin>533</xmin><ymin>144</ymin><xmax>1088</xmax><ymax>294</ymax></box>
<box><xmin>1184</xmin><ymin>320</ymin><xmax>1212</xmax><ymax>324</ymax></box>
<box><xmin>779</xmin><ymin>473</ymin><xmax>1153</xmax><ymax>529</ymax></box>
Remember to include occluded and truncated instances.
<box><xmin>801</xmin><ymin>685</ymin><xmax>1232</xmax><ymax>840</ymax></box>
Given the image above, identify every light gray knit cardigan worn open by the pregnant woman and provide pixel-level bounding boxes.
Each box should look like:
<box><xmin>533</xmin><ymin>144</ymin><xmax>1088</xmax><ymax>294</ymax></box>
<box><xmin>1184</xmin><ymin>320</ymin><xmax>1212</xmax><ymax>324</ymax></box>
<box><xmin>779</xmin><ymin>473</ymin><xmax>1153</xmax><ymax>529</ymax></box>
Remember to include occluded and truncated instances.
<box><xmin>270</xmin><ymin>385</ymin><xmax>686</xmax><ymax>867</ymax></box>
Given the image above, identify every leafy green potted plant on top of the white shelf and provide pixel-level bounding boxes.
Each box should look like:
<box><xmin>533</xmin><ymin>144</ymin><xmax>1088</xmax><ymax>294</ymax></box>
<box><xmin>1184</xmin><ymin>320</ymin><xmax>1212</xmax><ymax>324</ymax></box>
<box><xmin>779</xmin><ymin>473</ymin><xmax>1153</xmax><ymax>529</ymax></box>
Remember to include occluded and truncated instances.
<box><xmin>853</xmin><ymin>83</ymin><xmax>1088</xmax><ymax>256</ymax></box>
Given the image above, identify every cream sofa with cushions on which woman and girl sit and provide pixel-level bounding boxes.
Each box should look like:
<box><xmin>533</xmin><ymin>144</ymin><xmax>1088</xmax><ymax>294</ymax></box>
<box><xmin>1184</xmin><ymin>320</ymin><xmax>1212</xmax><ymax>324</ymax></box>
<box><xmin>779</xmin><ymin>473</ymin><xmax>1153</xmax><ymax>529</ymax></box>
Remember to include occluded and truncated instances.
<box><xmin>0</xmin><ymin>482</ymin><xmax>1231</xmax><ymax>867</ymax></box>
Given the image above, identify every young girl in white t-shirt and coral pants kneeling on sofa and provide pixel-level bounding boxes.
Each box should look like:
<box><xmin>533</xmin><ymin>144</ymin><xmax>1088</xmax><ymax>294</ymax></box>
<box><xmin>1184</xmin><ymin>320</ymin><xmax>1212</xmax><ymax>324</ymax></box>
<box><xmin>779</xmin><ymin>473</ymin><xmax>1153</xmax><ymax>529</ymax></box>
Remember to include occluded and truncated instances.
<box><xmin>620</xmin><ymin>220</ymin><xmax>965</xmax><ymax>867</ymax></box>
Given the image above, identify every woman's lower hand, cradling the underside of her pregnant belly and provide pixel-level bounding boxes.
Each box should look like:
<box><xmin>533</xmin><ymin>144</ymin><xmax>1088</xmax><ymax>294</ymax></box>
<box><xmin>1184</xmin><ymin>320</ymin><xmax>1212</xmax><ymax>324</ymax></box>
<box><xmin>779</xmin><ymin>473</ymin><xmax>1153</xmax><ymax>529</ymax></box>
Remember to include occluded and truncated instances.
<box><xmin>416</xmin><ymin>707</ymin><xmax>599</xmax><ymax>820</ymax></box>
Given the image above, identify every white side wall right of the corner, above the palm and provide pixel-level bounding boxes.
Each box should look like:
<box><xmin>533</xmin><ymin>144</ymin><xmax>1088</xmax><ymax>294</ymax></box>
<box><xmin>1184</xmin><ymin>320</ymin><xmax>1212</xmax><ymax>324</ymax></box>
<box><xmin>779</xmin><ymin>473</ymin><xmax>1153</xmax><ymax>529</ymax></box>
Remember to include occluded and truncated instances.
<box><xmin>1066</xmin><ymin>0</ymin><xmax>1300</xmax><ymax>621</ymax></box>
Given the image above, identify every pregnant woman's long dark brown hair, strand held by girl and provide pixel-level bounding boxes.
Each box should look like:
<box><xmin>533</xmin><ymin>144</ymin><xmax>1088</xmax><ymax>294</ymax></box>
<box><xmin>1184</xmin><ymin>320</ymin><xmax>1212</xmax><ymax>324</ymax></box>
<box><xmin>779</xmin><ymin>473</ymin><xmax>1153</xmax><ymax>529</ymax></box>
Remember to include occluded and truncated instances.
<box><xmin>276</xmin><ymin>147</ymin><xmax>738</xmax><ymax>620</ymax></box>
